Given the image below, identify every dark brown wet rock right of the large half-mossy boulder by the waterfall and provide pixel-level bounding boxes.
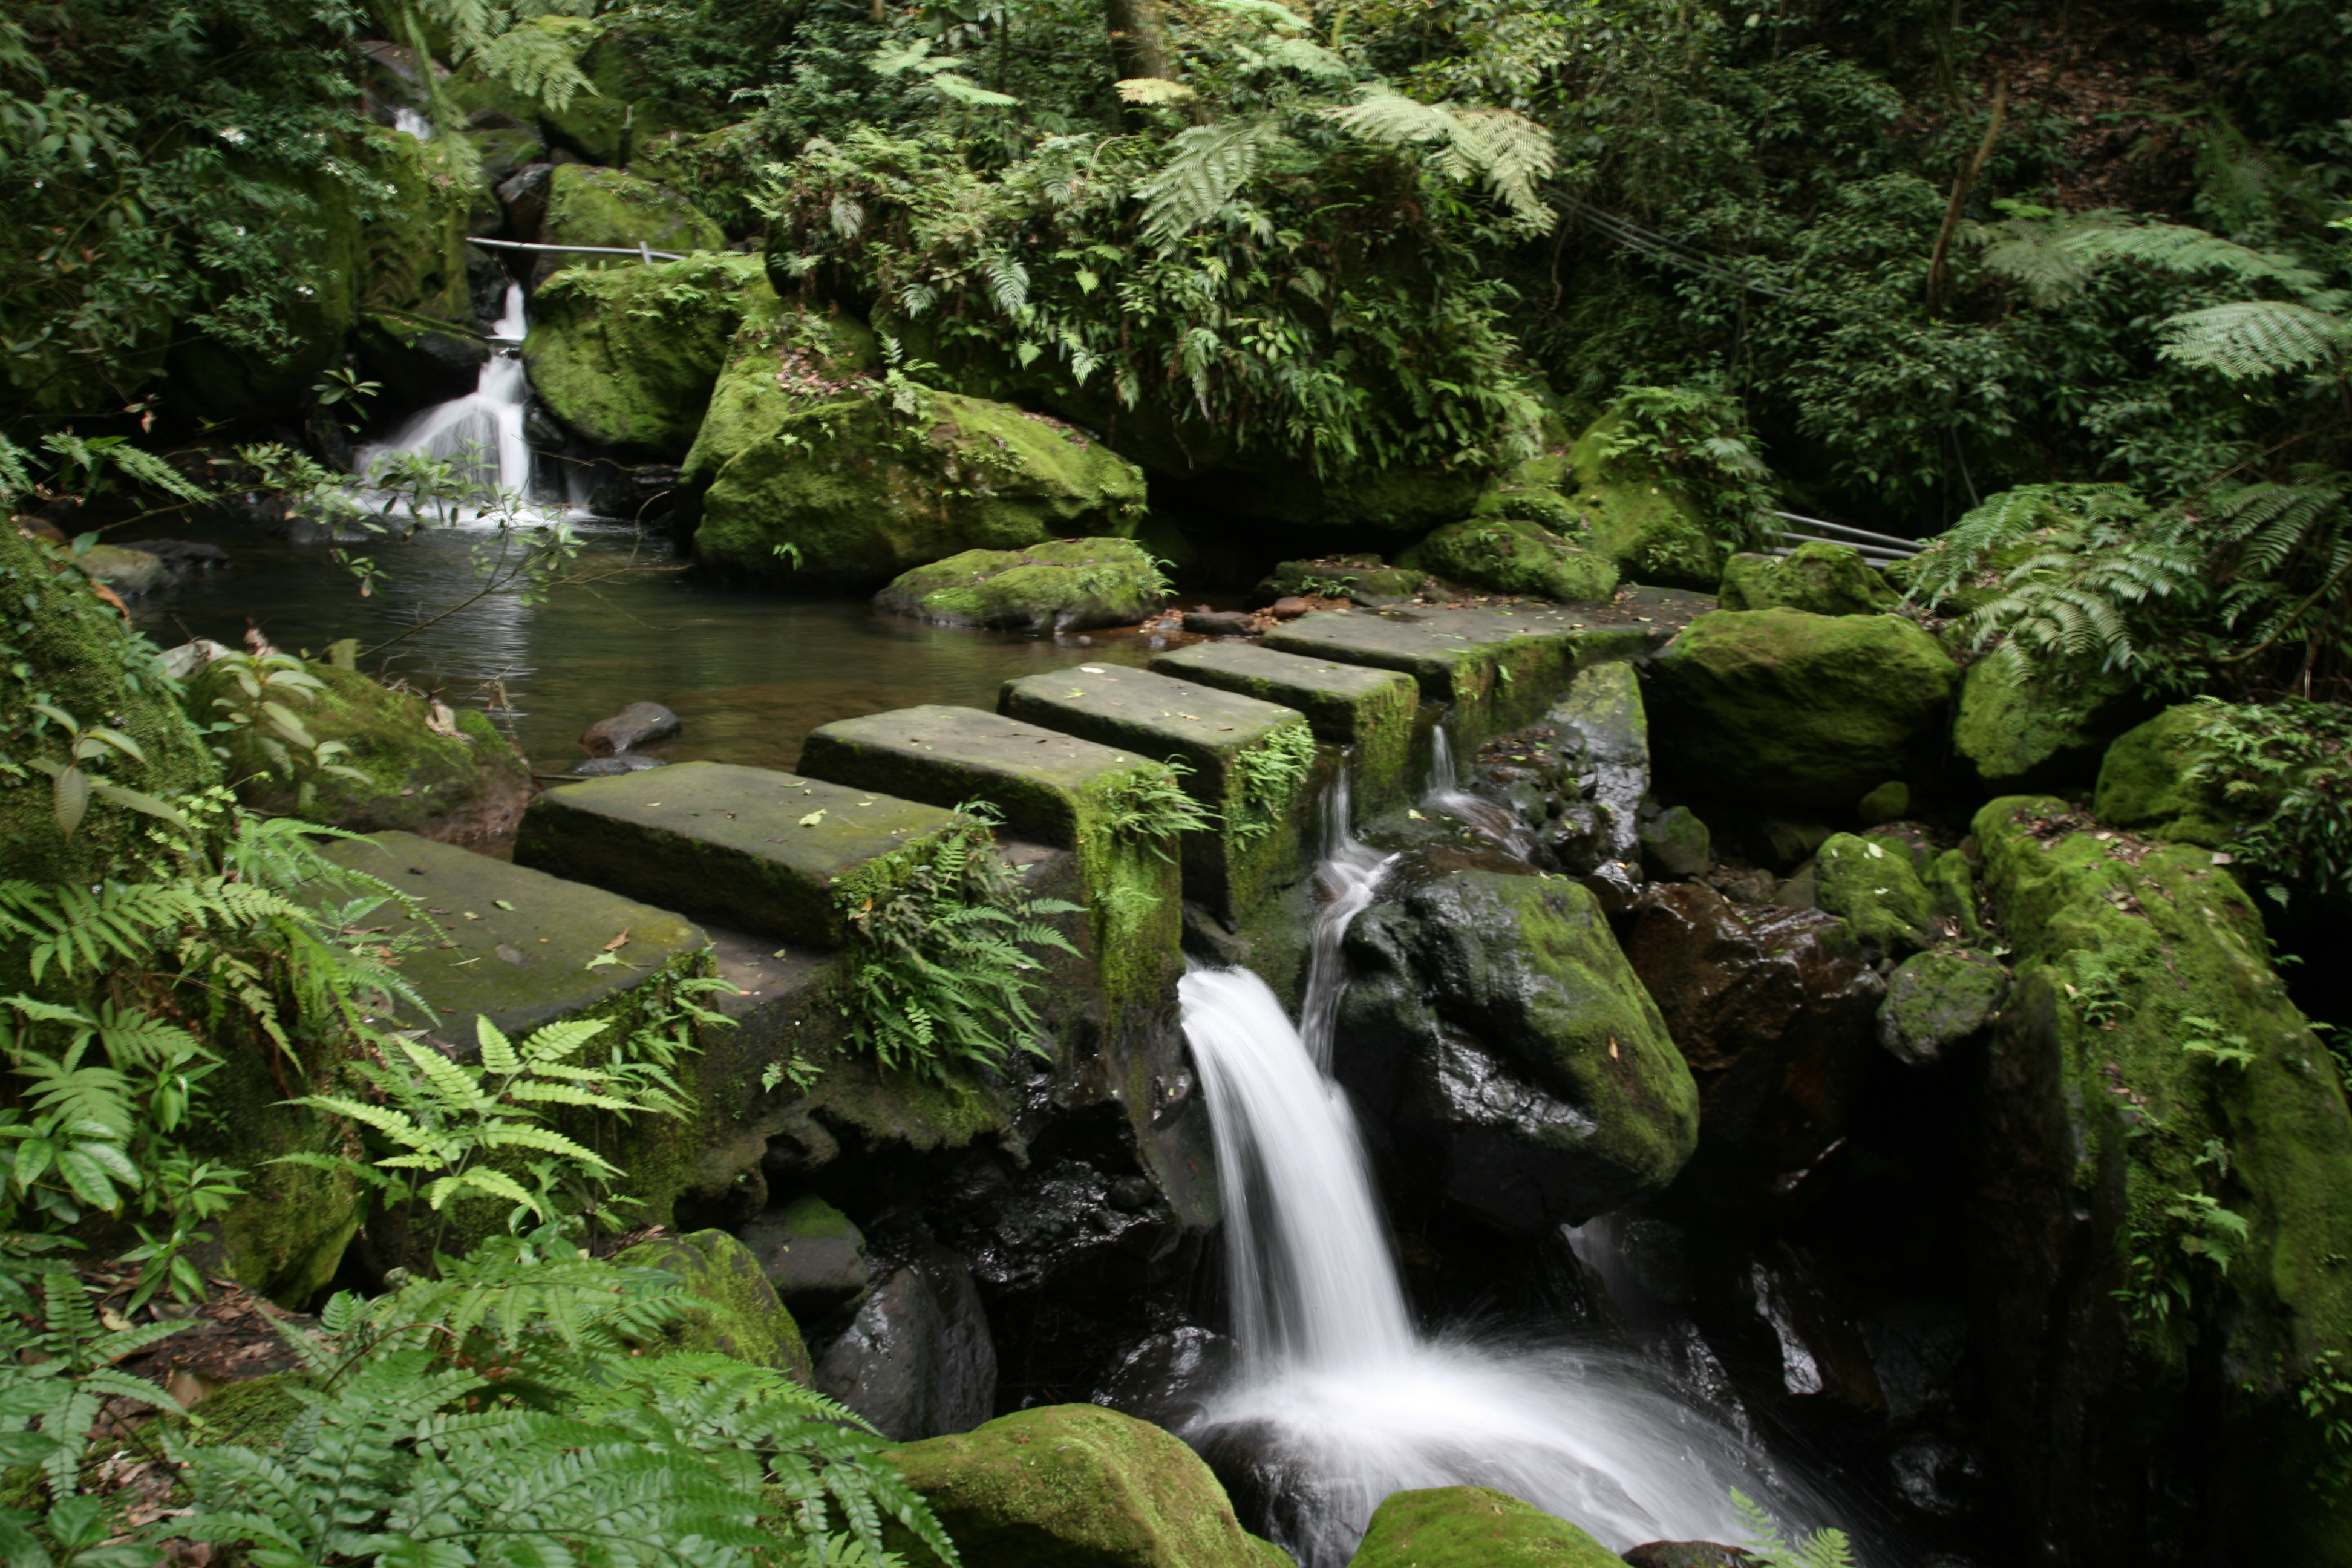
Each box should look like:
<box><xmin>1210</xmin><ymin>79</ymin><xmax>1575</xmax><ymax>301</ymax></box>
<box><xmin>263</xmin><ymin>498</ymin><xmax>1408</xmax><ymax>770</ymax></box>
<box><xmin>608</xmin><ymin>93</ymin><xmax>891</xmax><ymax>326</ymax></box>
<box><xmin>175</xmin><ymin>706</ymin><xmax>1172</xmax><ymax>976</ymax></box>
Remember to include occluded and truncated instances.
<box><xmin>1625</xmin><ymin>881</ymin><xmax>1884</xmax><ymax>1201</ymax></box>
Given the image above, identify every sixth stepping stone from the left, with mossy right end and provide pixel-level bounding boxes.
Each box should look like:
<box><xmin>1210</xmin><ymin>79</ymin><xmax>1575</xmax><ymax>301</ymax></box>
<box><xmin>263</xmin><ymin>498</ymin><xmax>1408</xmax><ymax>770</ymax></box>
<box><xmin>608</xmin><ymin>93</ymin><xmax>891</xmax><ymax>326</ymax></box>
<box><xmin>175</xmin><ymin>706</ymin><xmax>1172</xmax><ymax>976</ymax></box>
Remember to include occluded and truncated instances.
<box><xmin>1266</xmin><ymin>609</ymin><xmax>1581</xmax><ymax>753</ymax></box>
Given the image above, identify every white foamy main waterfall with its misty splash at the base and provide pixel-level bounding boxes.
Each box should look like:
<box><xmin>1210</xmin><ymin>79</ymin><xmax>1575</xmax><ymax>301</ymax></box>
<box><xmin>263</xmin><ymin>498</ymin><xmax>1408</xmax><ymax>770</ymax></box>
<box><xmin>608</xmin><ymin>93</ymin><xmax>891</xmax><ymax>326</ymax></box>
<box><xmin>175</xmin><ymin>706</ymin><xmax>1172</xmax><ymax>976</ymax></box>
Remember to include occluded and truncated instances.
<box><xmin>1178</xmin><ymin>964</ymin><xmax>1814</xmax><ymax>1568</ymax></box>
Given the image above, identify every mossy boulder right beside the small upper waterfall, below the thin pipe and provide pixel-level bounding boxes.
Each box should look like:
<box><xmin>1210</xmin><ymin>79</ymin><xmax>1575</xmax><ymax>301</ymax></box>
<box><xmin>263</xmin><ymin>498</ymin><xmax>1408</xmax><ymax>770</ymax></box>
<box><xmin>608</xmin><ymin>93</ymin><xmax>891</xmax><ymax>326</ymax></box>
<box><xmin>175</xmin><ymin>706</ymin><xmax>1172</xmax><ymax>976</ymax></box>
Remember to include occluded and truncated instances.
<box><xmin>522</xmin><ymin>254</ymin><xmax>774</xmax><ymax>461</ymax></box>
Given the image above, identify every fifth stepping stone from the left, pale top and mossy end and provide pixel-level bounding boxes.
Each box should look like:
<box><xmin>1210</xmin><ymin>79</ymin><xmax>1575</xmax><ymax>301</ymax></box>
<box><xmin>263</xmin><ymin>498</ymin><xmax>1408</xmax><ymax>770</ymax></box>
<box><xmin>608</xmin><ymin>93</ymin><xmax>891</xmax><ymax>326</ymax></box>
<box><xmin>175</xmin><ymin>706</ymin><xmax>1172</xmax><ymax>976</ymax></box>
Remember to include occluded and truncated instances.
<box><xmin>1152</xmin><ymin>642</ymin><xmax>1420</xmax><ymax>818</ymax></box>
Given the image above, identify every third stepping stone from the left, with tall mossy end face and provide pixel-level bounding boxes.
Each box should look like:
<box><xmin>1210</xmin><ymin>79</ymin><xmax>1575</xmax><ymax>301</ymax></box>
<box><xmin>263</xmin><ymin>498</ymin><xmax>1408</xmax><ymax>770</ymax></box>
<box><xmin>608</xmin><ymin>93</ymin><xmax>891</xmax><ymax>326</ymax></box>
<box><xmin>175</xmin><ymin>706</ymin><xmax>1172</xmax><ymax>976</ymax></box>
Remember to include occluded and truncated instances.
<box><xmin>800</xmin><ymin>703</ymin><xmax>1183</xmax><ymax>1030</ymax></box>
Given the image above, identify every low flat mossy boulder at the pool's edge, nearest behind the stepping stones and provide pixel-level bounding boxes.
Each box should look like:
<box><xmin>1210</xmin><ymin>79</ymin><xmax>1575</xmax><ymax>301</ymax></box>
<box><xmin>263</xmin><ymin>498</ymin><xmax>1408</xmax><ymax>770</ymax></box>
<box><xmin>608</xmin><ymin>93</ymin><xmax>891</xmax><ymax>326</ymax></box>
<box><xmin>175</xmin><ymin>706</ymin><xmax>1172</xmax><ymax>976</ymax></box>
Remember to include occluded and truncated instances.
<box><xmin>875</xmin><ymin>538</ymin><xmax>1166</xmax><ymax>632</ymax></box>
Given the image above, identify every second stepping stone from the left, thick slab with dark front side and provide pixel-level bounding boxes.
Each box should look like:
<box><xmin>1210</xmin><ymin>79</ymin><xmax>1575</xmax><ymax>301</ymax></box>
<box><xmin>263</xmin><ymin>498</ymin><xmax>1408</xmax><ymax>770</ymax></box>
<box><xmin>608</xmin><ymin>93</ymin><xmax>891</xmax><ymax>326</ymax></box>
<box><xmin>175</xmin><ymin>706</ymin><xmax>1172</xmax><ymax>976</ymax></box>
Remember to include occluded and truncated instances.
<box><xmin>515</xmin><ymin>762</ymin><xmax>955</xmax><ymax>947</ymax></box>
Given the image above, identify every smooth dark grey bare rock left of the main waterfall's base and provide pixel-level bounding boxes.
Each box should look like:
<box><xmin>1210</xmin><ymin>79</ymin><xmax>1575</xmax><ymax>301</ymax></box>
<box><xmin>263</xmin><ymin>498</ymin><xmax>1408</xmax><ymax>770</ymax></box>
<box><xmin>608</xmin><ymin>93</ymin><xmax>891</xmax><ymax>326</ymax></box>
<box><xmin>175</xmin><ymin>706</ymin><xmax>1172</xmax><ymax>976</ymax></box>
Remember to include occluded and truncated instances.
<box><xmin>816</xmin><ymin>1244</ymin><xmax>998</xmax><ymax>1441</ymax></box>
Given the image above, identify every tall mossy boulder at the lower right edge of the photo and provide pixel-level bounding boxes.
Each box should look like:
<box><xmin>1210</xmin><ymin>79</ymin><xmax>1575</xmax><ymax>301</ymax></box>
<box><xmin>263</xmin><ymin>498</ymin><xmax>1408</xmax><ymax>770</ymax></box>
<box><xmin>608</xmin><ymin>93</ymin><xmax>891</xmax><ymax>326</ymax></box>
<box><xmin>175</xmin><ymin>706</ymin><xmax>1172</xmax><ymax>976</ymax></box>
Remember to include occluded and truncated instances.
<box><xmin>1968</xmin><ymin>797</ymin><xmax>2352</xmax><ymax>1566</ymax></box>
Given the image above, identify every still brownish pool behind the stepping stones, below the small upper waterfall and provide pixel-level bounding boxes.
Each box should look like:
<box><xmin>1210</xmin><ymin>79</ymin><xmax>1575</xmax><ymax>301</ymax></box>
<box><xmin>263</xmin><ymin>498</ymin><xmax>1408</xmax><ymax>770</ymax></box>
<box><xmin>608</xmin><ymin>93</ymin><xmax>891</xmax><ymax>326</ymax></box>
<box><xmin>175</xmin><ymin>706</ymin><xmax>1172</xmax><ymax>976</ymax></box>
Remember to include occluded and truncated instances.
<box><xmin>116</xmin><ymin>524</ymin><xmax>1155</xmax><ymax>774</ymax></box>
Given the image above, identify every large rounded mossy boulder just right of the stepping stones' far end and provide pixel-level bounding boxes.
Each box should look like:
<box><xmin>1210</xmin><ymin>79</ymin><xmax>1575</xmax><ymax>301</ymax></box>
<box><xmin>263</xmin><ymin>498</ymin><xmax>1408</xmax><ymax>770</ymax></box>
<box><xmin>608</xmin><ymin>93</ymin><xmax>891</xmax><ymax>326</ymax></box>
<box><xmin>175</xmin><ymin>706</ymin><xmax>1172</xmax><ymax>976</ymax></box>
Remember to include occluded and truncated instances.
<box><xmin>1648</xmin><ymin>609</ymin><xmax>1959</xmax><ymax>811</ymax></box>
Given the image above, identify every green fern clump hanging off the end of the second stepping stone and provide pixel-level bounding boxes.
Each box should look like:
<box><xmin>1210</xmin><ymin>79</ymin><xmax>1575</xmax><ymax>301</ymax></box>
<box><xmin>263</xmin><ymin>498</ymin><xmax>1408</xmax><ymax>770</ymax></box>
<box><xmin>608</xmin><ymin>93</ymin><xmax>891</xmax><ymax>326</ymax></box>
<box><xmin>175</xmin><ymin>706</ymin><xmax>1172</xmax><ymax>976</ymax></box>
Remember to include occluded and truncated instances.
<box><xmin>832</xmin><ymin>802</ymin><xmax>1082</xmax><ymax>1079</ymax></box>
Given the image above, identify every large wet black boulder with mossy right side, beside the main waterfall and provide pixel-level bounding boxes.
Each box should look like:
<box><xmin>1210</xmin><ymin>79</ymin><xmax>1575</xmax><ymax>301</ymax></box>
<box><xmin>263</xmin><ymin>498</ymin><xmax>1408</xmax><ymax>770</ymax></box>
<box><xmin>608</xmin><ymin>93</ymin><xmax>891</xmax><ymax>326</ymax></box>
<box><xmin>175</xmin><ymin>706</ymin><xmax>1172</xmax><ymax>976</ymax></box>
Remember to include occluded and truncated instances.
<box><xmin>1338</xmin><ymin>870</ymin><xmax>1698</xmax><ymax>1232</ymax></box>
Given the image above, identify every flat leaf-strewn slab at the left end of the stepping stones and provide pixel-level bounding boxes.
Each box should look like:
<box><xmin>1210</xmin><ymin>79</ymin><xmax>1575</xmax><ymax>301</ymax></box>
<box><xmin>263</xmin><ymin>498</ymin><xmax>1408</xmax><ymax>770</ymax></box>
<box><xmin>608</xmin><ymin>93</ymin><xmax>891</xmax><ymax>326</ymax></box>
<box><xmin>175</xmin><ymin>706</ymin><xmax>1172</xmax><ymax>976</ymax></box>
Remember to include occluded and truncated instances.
<box><xmin>325</xmin><ymin>832</ymin><xmax>710</xmax><ymax>1044</ymax></box>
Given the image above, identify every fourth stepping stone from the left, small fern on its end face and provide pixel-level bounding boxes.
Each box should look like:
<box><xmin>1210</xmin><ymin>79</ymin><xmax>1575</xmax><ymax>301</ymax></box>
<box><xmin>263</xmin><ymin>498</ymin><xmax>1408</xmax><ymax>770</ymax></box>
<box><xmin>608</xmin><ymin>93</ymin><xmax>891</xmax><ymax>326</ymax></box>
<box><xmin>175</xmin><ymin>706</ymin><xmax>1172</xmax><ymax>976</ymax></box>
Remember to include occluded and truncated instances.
<box><xmin>998</xmin><ymin>665</ymin><xmax>1313</xmax><ymax>921</ymax></box>
